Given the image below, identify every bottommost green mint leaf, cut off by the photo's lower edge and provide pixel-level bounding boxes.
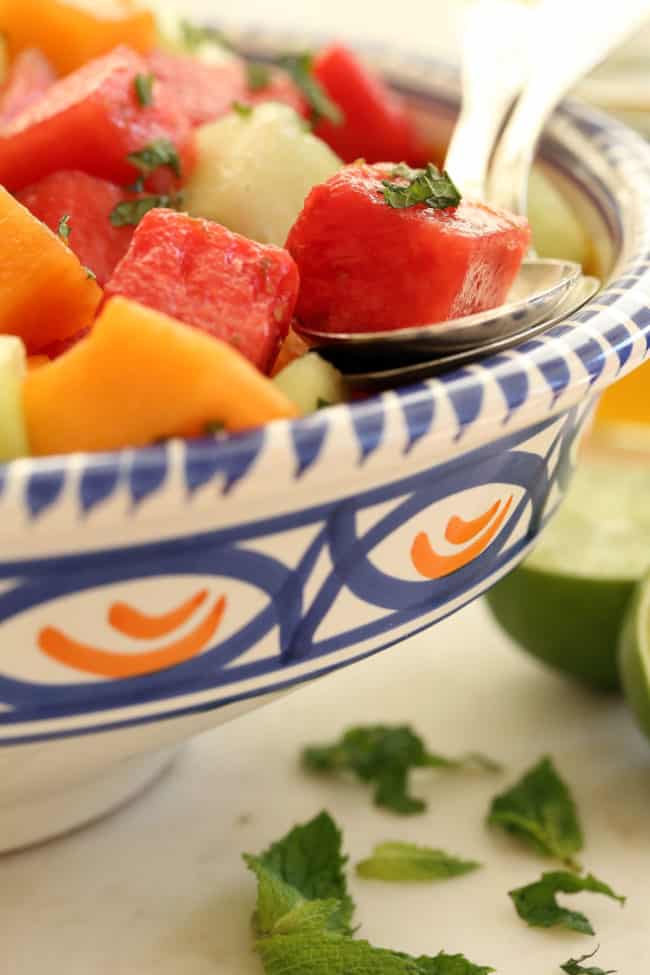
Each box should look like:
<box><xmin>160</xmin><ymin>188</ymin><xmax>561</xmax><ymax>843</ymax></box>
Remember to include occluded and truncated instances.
<box><xmin>256</xmin><ymin>932</ymin><xmax>494</xmax><ymax>975</ymax></box>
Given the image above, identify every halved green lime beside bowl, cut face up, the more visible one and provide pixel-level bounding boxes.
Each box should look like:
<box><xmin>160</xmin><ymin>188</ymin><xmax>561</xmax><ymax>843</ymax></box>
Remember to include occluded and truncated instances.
<box><xmin>487</xmin><ymin>451</ymin><xmax>650</xmax><ymax>690</ymax></box>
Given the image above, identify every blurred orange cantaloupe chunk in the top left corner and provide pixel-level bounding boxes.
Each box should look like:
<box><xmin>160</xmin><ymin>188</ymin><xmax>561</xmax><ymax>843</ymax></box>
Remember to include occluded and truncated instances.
<box><xmin>0</xmin><ymin>0</ymin><xmax>156</xmax><ymax>74</ymax></box>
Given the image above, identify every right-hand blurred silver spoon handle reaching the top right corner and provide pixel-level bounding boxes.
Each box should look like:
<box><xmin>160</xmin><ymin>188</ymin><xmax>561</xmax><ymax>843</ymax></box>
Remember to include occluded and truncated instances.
<box><xmin>488</xmin><ymin>0</ymin><xmax>650</xmax><ymax>214</ymax></box>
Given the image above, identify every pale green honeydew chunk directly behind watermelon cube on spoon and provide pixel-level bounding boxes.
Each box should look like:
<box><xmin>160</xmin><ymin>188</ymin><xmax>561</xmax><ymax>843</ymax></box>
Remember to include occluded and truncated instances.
<box><xmin>185</xmin><ymin>102</ymin><xmax>342</xmax><ymax>246</ymax></box>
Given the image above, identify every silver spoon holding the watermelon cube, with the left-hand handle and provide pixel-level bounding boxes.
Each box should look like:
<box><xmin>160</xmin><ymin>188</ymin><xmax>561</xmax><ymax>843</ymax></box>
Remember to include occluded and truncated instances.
<box><xmin>298</xmin><ymin>0</ymin><xmax>581</xmax><ymax>359</ymax></box>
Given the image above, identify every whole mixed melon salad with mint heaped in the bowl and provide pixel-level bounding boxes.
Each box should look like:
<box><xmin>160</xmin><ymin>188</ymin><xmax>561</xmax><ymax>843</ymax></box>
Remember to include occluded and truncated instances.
<box><xmin>0</xmin><ymin>0</ymin><xmax>530</xmax><ymax>461</ymax></box>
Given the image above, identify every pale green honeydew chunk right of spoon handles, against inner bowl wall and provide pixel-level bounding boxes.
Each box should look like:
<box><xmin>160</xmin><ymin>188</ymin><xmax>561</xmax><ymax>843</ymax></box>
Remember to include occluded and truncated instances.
<box><xmin>528</xmin><ymin>166</ymin><xmax>590</xmax><ymax>265</ymax></box>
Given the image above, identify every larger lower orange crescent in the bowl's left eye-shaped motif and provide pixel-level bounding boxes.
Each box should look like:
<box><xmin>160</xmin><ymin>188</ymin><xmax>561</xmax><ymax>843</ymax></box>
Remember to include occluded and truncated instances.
<box><xmin>38</xmin><ymin>596</ymin><xmax>226</xmax><ymax>678</ymax></box>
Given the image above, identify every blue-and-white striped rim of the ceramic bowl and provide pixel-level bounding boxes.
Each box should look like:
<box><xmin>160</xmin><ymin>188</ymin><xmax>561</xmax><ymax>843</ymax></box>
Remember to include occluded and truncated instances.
<box><xmin>0</xmin><ymin>41</ymin><xmax>650</xmax><ymax>535</ymax></box>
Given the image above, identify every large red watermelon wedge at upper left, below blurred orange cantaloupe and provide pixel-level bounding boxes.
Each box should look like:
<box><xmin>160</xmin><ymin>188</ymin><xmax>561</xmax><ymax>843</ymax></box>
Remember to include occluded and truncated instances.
<box><xmin>0</xmin><ymin>47</ymin><xmax>194</xmax><ymax>192</ymax></box>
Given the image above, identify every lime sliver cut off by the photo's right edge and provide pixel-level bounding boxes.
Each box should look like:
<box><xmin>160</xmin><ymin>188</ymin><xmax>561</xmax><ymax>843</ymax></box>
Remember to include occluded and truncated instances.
<box><xmin>618</xmin><ymin>575</ymin><xmax>650</xmax><ymax>738</ymax></box>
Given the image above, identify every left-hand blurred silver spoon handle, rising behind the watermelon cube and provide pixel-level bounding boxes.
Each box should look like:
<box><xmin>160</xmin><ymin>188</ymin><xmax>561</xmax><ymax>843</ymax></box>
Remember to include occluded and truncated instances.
<box><xmin>445</xmin><ymin>0</ymin><xmax>536</xmax><ymax>200</ymax></box>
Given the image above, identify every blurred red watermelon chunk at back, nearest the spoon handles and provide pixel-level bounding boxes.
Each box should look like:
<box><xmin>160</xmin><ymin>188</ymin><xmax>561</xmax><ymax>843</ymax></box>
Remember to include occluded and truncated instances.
<box><xmin>313</xmin><ymin>44</ymin><xmax>431</xmax><ymax>166</ymax></box>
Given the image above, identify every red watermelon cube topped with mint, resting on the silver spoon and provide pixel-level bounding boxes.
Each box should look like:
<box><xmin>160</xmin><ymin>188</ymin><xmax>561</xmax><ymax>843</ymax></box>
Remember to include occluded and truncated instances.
<box><xmin>287</xmin><ymin>163</ymin><xmax>530</xmax><ymax>332</ymax></box>
